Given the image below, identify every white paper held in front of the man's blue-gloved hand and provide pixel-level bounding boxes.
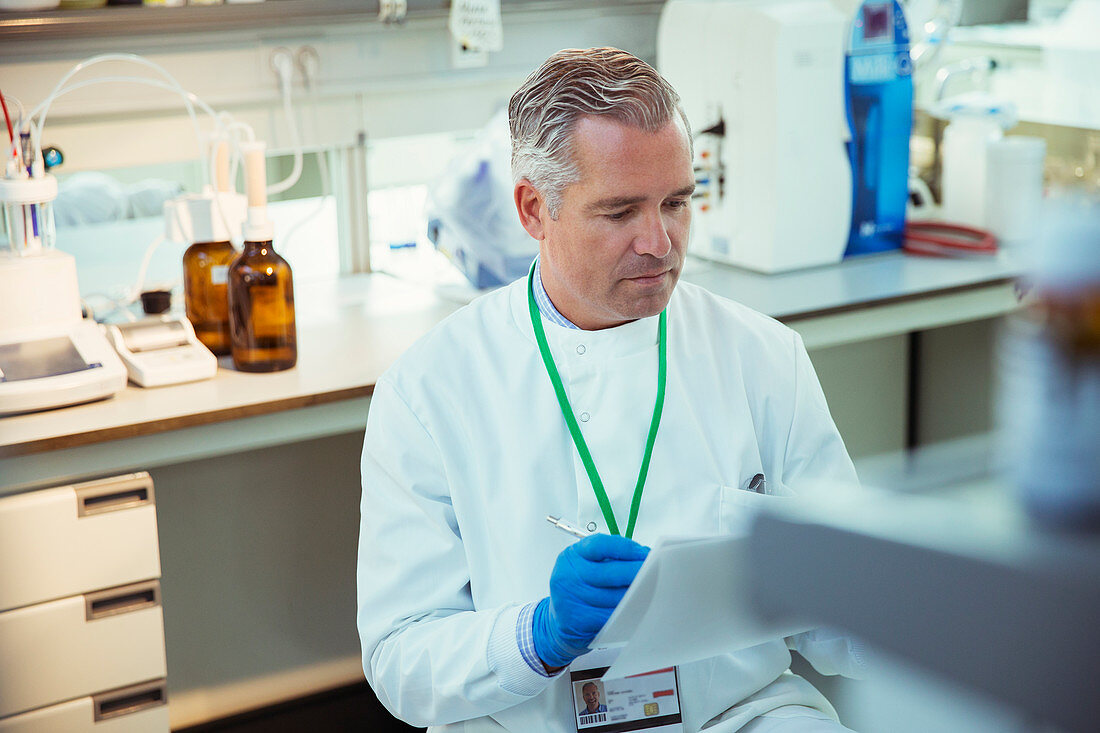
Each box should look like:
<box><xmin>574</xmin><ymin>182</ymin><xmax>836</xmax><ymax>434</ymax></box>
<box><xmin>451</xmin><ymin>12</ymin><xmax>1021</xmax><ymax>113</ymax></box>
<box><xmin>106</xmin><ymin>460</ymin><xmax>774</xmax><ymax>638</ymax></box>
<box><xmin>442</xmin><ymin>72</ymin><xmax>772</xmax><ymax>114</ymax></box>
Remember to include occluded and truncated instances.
<box><xmin>592</xmin><ymin>535</ymin><xmax>812</xmax><ymax>678</ymax></box>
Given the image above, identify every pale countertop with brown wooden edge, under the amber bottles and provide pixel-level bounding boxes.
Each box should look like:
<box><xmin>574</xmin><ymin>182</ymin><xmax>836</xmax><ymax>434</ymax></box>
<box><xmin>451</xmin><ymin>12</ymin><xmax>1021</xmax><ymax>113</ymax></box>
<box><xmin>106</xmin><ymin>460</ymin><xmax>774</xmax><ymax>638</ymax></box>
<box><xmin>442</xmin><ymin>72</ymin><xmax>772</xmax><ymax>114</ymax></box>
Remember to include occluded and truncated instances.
<box><xmin>0</xmin><ymin>275</ymin><xmax>458</xmax><ymax>458</ymax></box>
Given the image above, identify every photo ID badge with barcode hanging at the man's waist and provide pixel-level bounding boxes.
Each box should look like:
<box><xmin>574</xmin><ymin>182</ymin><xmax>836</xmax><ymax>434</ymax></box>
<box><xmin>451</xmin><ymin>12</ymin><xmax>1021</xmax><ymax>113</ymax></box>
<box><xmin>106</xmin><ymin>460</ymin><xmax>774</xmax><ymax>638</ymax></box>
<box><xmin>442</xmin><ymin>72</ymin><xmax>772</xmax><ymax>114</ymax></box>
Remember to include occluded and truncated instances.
<box><xmin>569</xmin><ymin>649</ymin><xmax>684</xmax><ymax>733</ymax></box>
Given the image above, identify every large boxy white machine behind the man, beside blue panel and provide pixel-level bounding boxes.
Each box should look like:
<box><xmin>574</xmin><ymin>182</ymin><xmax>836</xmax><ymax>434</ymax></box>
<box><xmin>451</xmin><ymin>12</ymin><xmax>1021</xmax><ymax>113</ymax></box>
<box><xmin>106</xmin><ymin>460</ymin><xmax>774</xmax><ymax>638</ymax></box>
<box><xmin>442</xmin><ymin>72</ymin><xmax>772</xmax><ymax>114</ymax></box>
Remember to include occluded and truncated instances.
<box><xmin>657</xmin><ymin>0</ymin><xmax>851</xmax><ymax>273</ymax></box>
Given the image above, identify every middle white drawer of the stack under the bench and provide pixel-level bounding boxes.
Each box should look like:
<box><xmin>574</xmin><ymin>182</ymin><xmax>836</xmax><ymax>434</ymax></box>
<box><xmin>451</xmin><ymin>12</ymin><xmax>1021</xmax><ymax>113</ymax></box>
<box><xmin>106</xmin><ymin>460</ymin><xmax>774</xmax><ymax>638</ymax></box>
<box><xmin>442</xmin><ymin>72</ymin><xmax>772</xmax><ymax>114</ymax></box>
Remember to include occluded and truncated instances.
<box><xmin>0</xmin><ymin>580</ymin><xmax>167</xmax><ymax>718</ymax></box>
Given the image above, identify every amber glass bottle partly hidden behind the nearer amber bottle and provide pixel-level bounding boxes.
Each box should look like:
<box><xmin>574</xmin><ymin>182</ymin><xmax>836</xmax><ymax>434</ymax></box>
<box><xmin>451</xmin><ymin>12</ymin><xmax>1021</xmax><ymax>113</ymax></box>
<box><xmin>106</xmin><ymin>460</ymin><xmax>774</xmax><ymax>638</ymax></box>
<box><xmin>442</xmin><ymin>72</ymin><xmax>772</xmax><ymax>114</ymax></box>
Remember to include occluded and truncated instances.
<box><xmin>184</xmin><ymin>242</ymin><xmax>237</xmax><ymax>355</ymax></box>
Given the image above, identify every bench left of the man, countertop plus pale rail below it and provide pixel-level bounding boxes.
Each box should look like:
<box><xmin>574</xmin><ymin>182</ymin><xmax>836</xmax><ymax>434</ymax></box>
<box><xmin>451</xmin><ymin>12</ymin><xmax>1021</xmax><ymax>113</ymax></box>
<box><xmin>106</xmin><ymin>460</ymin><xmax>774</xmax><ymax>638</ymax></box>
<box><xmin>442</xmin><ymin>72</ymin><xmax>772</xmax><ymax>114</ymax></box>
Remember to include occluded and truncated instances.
<box><xmin>0</xmin><ymin>275</ymin><xmax>459</xmax><ymax>493</ymax></box>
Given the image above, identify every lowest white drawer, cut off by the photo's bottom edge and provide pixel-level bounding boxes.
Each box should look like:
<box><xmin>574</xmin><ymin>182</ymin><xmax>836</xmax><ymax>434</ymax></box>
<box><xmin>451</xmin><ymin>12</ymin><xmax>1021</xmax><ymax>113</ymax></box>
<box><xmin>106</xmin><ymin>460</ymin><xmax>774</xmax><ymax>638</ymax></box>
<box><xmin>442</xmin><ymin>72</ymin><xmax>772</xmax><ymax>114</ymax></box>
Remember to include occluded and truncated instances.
<box><xmin>0</xmin><ymin>679</ymin><xmax>169</xmax><ymax>733</ymax></box>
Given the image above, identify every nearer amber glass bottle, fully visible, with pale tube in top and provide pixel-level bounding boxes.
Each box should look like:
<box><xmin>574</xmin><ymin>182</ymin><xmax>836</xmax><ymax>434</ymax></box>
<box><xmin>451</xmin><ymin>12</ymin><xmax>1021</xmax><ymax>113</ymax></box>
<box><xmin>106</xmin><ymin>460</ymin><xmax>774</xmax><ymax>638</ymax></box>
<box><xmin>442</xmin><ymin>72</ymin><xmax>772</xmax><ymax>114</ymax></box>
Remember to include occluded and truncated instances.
<box><xmin>229</xmin><ymin>240</ymin><xmax>298</xmax><ymax>372</ymax></box>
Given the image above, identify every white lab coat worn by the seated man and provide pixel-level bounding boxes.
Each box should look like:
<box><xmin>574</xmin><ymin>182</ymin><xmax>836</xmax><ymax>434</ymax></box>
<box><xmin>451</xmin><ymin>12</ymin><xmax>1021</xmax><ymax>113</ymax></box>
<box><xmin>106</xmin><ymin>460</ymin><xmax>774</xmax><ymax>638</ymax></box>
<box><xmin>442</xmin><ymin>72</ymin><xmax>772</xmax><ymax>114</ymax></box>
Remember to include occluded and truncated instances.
<box><xmin>358</xmin><ymin>278</ymin><xmax>859</xmax><ymax>733</ymax></box>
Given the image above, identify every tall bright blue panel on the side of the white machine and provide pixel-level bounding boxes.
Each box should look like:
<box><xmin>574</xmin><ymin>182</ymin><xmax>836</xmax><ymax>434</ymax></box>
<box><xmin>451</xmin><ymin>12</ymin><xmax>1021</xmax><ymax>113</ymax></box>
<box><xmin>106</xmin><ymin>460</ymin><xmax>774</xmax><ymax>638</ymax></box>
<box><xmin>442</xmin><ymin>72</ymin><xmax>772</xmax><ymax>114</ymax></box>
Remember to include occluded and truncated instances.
<box><xmin>845</xmin><ymin>0</ymin><xmax>913</xmax><ymax>256</ymax></box>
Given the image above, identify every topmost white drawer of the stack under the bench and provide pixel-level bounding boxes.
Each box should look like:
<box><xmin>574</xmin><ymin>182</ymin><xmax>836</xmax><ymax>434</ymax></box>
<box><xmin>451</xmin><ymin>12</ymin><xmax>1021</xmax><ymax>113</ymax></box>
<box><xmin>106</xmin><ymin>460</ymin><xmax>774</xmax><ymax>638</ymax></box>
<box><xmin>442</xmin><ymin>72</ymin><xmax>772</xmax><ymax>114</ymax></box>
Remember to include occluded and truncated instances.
<box><xmin>0</xmin><ymin>473</ymin><xmax>161</xmax><ymax>611</ymax></box>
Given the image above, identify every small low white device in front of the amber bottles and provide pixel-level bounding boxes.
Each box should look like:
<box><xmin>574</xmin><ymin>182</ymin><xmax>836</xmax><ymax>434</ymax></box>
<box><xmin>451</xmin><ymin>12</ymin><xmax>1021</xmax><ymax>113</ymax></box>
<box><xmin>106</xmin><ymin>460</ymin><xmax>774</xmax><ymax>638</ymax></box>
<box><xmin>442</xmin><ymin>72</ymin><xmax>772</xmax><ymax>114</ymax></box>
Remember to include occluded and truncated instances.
<box><xmin>107</xmin><ymin>316</ymin><xmax>218</xmax><ymax>387</ymax></box>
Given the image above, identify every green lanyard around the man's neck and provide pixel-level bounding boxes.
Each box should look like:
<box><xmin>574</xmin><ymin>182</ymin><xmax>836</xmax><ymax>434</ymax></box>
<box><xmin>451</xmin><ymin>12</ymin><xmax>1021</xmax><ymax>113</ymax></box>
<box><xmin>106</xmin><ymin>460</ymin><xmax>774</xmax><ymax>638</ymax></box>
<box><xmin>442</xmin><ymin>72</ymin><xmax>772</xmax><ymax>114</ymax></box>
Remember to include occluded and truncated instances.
<box><xmin>527</xmin><ymin>264</ymin><xmax>669</xmax><ymax>539</ymax></box>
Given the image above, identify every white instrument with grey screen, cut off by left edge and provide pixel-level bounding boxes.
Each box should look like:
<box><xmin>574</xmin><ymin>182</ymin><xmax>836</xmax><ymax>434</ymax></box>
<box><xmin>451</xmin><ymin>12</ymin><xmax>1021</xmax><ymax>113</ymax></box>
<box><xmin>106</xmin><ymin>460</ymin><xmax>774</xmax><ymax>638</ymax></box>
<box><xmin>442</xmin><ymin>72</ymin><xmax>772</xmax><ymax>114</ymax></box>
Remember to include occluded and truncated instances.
<box><xmin>0</xmin><ymin>175</ymin><xmax>127</xmax><ymax>415</ymax></box>
